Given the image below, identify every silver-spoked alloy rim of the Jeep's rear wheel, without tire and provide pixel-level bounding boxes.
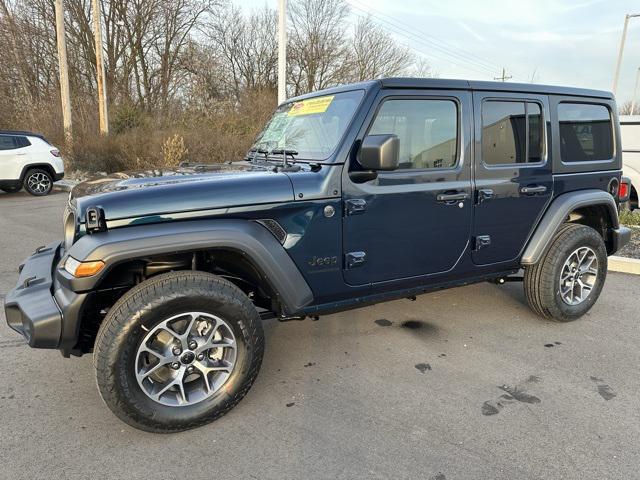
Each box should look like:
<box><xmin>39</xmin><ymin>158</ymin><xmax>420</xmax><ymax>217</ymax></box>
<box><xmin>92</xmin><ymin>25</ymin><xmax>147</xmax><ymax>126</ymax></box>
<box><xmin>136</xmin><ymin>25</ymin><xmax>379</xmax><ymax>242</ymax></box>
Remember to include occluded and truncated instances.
<box><xmin>560</xmin><ymin>247</ymin><xmax>598</xmax><ymax>306</ymax></box>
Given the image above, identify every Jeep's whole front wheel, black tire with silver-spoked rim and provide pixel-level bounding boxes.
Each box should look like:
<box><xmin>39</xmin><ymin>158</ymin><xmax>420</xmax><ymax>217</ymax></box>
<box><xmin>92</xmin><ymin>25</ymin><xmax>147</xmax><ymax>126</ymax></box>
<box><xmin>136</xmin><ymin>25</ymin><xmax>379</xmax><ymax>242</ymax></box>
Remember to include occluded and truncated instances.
<box><xmin>94</xmin><ymin>272</ymin><xmax>264</xmax><ymax>432</ymax></box>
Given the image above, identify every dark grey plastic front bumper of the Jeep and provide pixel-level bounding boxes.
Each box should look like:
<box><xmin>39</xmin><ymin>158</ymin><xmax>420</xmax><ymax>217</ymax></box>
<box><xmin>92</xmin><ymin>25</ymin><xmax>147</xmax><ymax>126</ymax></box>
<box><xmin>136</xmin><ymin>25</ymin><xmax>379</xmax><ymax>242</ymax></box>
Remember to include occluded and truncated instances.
<box><xmin>4</xmin><ymin>242</ymin><xmax>86</xmax><ymax>353</ymax></box>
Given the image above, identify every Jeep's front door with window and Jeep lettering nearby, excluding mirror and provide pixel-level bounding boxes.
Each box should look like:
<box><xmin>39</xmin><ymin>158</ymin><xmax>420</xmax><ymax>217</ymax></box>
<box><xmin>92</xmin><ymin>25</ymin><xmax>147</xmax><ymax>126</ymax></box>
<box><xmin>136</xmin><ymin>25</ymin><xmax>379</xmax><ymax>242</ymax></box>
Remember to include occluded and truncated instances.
<box><xmin>343</xmin><ymin>90</ymin><xmax>473</xmax><ymax>285</ymax></box>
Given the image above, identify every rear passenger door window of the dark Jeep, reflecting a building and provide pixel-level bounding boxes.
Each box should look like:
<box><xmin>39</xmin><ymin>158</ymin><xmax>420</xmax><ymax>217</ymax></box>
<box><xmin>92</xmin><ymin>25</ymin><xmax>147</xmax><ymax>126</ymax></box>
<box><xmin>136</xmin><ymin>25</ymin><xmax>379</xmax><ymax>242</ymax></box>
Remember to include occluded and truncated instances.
<box><xmin>482</xmin><ymin>100</ymin><xmax>544</xmax><ymax>165</ymax></box>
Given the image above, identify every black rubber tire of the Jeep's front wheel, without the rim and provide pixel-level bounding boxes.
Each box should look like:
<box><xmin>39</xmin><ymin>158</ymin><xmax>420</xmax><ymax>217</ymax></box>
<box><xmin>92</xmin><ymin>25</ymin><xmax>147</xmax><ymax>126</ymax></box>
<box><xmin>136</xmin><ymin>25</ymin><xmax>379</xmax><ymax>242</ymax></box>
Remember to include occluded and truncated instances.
<box><xmin>94</xmin><ymin>271</ymin><xmax>264</xmax><ymax>433</ymax></box>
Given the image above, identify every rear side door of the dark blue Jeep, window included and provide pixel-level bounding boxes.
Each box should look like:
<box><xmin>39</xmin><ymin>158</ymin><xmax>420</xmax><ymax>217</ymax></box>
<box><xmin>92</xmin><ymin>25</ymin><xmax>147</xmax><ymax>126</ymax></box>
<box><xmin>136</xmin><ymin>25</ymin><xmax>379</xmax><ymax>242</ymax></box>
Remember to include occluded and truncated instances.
<box><xmin>472</xmin><ymin>92</ymin><xmax>553</xmax><ymax>265</ymax></box>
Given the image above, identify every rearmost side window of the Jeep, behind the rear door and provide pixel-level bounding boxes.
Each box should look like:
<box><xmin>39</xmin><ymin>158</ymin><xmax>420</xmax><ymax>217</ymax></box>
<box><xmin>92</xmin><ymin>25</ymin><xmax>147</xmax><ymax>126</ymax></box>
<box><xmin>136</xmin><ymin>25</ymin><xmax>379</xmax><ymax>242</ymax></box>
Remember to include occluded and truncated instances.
<box><xmin>558</xmin><ymin>103</ymin><xmax>613</xmax><ymax>162</ymax></box>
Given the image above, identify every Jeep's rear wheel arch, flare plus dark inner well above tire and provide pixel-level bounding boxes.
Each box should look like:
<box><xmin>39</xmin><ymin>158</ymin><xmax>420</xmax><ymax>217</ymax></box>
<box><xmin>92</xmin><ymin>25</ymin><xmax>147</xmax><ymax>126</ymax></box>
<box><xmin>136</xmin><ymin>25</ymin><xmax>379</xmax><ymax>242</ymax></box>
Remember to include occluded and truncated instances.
<box><xmin>521</xmin><ymin>189</ymin><xmax>620</xmax><ymax>266</ymax></box>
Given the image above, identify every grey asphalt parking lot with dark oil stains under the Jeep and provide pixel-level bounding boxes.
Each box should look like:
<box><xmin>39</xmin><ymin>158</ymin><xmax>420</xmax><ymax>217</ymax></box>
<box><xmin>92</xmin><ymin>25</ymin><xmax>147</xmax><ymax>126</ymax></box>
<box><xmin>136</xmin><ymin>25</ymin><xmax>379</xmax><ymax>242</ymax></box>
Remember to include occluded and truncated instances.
<box><xmin>0</xmin><ymin>189</ymin><xmax>640</xmax><ymax>480</ymax></box>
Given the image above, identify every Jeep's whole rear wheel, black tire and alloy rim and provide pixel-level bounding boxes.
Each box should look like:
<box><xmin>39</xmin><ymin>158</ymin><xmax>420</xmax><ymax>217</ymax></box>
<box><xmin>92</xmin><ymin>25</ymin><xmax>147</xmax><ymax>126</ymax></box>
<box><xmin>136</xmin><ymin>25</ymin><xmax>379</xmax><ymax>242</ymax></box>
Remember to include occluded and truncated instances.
<box><xmin>524</xmin><ymin>224</ymin><xmax>607</xmax><ymax>322</ymax></box>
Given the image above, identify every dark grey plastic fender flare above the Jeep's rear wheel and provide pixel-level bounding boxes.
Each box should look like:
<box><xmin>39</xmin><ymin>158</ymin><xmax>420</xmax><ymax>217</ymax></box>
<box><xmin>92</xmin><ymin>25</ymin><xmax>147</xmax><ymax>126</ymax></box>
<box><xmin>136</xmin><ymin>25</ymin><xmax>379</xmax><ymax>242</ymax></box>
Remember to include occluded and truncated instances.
<box><xmin>521</xmin><ymin>189</ymin><xmax>620</xmax><ymax>266</ymax></box>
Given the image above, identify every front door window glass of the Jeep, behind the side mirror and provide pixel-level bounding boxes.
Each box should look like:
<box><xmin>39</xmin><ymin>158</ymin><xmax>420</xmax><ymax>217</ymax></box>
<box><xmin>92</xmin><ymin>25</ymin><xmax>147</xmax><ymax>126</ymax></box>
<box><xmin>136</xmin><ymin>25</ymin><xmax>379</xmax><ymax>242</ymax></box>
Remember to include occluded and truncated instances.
<box><xmin>369</xmin><ymin>99</ymin><xmax>458</xmax><ymax>169</ymax></box>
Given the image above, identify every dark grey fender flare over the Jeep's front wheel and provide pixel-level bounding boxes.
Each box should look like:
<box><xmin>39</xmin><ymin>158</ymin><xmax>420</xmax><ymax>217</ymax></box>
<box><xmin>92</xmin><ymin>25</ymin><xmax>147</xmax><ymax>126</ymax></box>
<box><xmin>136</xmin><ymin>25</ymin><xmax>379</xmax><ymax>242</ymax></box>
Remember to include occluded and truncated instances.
<box><xmin>59</xmin><ymin>219</ymin><xmax>313</xmax><ymax>315</ymax></box>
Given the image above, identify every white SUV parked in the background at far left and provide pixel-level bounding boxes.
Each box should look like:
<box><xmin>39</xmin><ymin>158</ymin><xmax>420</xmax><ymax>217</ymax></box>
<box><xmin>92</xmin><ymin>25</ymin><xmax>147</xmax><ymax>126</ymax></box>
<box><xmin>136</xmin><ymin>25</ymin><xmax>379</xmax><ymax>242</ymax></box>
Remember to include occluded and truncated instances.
<box><xmin>0</xmin><ymin>130</ymin><xmax>64</xmax><ymax>196</ymax></box>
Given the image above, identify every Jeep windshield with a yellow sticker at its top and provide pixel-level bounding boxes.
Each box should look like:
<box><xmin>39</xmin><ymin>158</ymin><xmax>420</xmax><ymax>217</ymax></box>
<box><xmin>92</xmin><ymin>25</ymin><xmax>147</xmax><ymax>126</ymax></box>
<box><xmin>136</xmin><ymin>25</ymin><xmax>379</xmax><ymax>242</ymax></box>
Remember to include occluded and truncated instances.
<box><xmin>252</xmin><ymin>90</ymin><xmax>364</xmax><ymax>160</ymax></box>
